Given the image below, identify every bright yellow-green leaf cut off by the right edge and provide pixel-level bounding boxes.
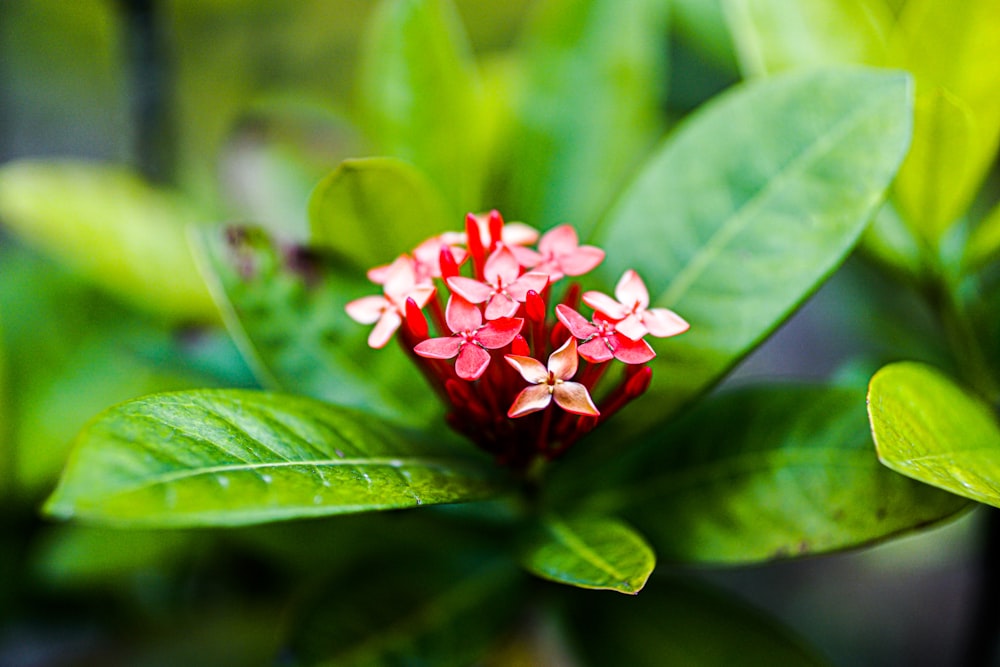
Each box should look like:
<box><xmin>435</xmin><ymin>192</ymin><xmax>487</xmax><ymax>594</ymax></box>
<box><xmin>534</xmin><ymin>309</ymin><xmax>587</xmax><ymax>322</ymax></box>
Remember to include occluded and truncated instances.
<box><xmin>868</xmin><ymin>362</ymin><xmax>1000</xmax><ymax>507</ymax></box>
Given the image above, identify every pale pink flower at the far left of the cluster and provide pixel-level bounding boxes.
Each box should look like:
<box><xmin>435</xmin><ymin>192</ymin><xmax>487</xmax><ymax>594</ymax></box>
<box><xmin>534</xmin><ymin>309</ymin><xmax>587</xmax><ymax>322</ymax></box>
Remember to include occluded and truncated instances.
<box><xmin>344</xmin><ymin>255</ymin><xmax>434</xmax><ymax>349</ymax></box>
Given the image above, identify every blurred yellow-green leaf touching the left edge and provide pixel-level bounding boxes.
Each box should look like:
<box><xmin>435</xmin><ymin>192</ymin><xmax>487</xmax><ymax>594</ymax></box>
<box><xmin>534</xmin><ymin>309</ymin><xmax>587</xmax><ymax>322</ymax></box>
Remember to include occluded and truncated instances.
<box><xmin>0</xmin><ymin>160</ymin><xmax>218</xmax><ymax>321</ymax></box>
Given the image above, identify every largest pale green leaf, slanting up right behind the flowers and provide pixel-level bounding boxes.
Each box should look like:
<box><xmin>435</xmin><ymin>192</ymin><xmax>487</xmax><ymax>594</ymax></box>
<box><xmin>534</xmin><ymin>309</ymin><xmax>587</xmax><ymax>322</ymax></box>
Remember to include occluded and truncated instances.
<box><xmin>597</xmin><ymin>68</ymin><xmax>911</xmax><ymax>426</ymax></box>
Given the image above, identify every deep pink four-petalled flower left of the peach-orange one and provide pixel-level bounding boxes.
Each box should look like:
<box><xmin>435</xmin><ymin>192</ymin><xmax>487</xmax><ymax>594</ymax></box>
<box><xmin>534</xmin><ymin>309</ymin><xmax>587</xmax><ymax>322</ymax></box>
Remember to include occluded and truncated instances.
<box><xmin>413</xmin><ymin>295</ymin><xmax>524</xmax><ymax>380</ymax></box>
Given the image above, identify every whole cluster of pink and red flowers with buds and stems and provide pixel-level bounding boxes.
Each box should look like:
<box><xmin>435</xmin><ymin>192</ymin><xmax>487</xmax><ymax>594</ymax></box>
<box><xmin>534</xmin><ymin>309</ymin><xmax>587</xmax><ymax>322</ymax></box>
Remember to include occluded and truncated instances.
<box><xmin>347</xmin><ymin>211</ymin><xmax>688</xmax><ymax>469</ymax></box>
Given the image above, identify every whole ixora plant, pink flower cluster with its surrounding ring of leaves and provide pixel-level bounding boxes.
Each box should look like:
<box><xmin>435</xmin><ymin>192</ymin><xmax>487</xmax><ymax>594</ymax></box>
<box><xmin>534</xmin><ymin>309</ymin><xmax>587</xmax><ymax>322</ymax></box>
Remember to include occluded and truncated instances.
<box><xmin>33</xmin><ymin>68</ymin><xmax>967</xmax><ymax>665</ymax></box>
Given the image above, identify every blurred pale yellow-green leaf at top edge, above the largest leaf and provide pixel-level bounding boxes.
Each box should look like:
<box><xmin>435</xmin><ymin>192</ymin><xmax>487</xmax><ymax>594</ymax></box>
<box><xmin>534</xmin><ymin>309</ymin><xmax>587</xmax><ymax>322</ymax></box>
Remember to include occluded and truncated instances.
<box><xmin>724</xmin><ymin>0</ymin><xmax>894</xmax><ymax>76</ymax></box>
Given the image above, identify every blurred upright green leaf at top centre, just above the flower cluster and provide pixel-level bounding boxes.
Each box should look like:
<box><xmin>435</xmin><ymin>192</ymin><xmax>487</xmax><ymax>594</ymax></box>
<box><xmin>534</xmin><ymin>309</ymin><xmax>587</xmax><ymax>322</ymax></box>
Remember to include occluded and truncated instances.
<box><xmin>509</xmin><ymin>0</ymin><xmax>669</xmax><ymax>237</ymax></box>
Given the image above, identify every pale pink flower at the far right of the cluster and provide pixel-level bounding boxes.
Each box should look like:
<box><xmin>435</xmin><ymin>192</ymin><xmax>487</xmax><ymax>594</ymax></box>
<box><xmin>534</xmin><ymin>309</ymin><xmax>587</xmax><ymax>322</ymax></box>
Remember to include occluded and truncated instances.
<box><xmin>583</xmin><ymin>269</ymin><xmax>691</xmax><ymax>341</ymax></box>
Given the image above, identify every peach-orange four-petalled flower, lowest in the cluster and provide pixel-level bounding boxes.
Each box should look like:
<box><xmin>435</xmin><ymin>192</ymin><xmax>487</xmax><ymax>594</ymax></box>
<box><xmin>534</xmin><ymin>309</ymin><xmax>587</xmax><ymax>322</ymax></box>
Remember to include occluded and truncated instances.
<box><xmin>504</xmin><ymin>338</ymin><xmax>600</xmax><ymax>418</ymax></box>
